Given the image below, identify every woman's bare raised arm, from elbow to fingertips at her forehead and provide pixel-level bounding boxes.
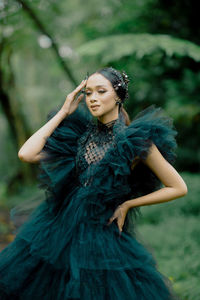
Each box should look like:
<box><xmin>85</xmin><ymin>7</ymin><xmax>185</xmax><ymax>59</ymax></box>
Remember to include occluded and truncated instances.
<box><xmin>18</xmin><ymin>80</ymin><xmax>86</xmax><ymax>163</ymax></box>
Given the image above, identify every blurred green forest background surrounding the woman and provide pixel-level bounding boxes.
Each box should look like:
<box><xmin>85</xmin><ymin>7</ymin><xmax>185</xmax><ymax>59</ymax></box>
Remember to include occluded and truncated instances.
<box><xmin>0</xmin><ymin>0</ymin><xmax>200</xmax><ymax>300</ymax></box>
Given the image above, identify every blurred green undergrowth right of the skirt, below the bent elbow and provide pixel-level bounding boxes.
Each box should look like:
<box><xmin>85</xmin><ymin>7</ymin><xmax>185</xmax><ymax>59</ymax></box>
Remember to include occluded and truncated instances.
<box><xmin>138</xmin><ymin>173</ymin><xmax>200</xmax><ymax>300</ymax></box>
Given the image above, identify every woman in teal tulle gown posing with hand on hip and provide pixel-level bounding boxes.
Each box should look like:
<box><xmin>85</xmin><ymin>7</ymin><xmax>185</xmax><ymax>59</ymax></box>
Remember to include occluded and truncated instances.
<box><xmin>0</xmin><ymin>68</ymin><xmax>187</xmax><ymax>300</ymax></box>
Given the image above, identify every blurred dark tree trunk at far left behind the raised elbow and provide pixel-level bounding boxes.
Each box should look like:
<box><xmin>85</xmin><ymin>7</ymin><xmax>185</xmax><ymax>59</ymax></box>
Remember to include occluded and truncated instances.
<box><xmin>0</xmin><ymin>42</ymin><xmax>36</xmax><ymax>191</ymax></box>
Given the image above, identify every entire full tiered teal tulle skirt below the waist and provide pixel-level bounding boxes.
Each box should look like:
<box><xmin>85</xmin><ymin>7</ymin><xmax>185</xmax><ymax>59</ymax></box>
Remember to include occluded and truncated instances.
<box><xmin>0</xmin><ymin>190</ymin><xmax>176</xmax><ymax>300</ymax></box>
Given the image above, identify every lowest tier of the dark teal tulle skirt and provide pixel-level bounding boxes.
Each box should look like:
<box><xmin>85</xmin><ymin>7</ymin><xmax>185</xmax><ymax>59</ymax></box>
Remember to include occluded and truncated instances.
<box><xmin>0</xmin><ymin>239</ymin><xmax>176</xmax><ymax>300</ymax></box>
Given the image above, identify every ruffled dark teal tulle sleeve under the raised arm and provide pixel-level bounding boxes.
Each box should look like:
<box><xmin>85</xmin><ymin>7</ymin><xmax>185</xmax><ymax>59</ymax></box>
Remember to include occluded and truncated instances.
<box><xmin>38</xmin><ymin>105</ymin><xmax>90</xmax><ymax>212</ymax></box>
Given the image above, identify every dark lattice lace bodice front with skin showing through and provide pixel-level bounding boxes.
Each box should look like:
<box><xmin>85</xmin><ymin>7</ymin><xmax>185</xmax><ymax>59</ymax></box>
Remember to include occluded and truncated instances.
<box><xmin>76</xmin><ymin>119</ymin><xmax>117</xmax><ymax>185</ymax></box>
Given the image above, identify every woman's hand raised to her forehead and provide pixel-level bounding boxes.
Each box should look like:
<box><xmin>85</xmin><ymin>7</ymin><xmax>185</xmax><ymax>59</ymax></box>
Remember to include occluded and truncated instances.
<box><xmin>60</xmin><ymin>79</ymin><xmax>87</xmax><ymax>115</ymax></box>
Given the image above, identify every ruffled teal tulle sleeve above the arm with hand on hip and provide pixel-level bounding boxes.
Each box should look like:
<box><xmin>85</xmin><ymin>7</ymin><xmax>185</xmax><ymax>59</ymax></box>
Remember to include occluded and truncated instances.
<box><xmin>125</xmin><ymin>105</ymin><xmax>177</xmax><ymax>196</ymax></box>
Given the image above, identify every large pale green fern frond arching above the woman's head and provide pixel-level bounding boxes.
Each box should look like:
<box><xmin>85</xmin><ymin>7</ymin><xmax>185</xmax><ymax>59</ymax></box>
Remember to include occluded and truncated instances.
<box><xmin>77</xmin><ymin>33</ymin><xmax>200</xmax><ymax>64</ymax></box>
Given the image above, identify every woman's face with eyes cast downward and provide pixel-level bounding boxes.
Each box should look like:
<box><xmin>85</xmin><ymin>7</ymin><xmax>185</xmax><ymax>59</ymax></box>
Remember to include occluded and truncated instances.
<box><xmin>85</xmin><ymin>73</ymin><xmax>118</xmax><ymax>121</ymax></box>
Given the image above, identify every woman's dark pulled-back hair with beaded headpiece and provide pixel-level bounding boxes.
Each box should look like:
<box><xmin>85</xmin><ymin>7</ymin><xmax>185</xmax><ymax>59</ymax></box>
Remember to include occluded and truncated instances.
<box><xmin>95</xmin><ymin>67</ymin><xmax>130</xmax><ymax>126</ymax></box>
